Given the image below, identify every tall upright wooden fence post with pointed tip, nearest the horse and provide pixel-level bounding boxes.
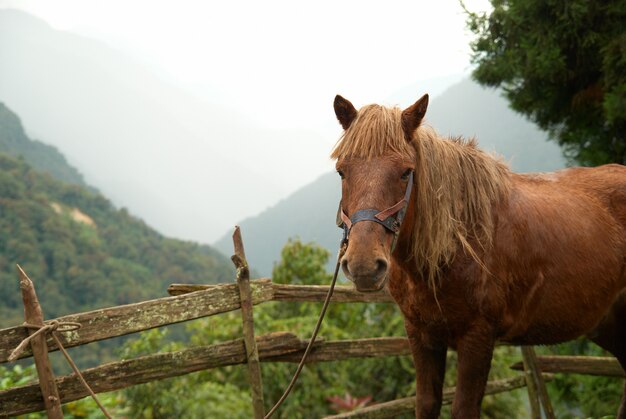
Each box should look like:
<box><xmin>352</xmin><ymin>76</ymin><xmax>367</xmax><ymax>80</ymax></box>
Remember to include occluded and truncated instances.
<box><xmin>231</xmin><ymin>226</ymin><xmax>265</xmax><ymax>419</ymax></box>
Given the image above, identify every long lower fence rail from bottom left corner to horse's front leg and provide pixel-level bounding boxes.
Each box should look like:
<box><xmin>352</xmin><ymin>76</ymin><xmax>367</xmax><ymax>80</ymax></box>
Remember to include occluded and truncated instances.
<box><xmin>0</xmin><ymin>332</ymin><xmax>409</xmax><ymax>417</ymax></box>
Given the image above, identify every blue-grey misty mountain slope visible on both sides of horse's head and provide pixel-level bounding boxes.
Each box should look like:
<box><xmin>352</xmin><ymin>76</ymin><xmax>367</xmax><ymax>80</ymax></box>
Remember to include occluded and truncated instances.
<box><xmin>215</xmin><ymin>80</ymin><xmax>565</xmax><ymax>275</ymax></box>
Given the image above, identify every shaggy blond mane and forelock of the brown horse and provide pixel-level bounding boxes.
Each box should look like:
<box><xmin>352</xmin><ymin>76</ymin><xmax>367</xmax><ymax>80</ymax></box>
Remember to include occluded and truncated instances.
<box><xmin>331</xmin><ymin>105</ymin><xmax>510</xmax><ymax>287</ymax></box>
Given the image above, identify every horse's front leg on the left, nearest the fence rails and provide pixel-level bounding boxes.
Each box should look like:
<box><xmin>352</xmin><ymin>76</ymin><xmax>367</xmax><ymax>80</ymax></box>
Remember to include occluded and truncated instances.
<box><xmin>406</xmin><ymin>323</ymin><xmax>447</xmax><ymax>419</ymax></box>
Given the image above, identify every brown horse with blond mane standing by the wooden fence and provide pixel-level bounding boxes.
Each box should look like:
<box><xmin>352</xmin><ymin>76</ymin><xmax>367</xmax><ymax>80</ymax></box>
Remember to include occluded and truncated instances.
<box><xmin>332</xmin><ymin>95</ymin><xmax>626</xmax><ymax>419</ymax></box>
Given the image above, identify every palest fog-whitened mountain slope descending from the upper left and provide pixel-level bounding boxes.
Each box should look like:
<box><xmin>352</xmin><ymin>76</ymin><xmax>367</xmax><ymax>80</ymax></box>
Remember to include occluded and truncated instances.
<box><xmin>0</xmin><ymin>9</ymin><xmax>328</xmax><ymax>242</ymax></box>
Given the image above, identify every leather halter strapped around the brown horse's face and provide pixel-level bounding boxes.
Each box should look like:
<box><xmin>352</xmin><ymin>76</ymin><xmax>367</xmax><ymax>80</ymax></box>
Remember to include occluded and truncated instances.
<box><xmin>337</xmin><ymin>172</ymin><xmax>413</xmax><ymax>252</ymax></box>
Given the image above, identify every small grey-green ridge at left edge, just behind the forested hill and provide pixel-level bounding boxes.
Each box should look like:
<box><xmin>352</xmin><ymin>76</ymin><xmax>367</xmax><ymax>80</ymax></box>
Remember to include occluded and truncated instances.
<box><xmin>0</xmin><ymin>102</ymin><xmax>86</xmax><ymax>186</ymax></box>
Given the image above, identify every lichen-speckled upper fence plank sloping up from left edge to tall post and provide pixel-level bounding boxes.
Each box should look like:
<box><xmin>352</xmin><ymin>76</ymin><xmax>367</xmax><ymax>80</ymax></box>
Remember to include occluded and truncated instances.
<box><xmin>0</xmin><ymin>281</ymin><xmax>273</xmax><ymax>363</ymax></box>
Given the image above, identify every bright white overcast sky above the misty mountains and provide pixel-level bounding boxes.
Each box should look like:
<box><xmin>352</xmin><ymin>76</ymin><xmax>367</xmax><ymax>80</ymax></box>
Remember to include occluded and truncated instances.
<box><xmin>0</xmin><ymin>0</ymin><xmax>490</xmax><ymax>127</ymax></box>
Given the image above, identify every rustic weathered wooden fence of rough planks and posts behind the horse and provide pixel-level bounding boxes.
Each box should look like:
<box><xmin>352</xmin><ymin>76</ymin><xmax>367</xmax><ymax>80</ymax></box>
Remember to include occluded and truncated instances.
<box><xmin>0</xmin><ymin>230</ymin><xmax>624</xmax><ymax>418</ymax></box>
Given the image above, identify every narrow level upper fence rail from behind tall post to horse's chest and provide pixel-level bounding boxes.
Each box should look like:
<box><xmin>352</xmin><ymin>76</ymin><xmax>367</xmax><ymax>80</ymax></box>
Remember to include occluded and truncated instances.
<box><xmin>167</xmin><ymin>278</ymin><xmax>394</xmax><ymax>303</ymax></box>
